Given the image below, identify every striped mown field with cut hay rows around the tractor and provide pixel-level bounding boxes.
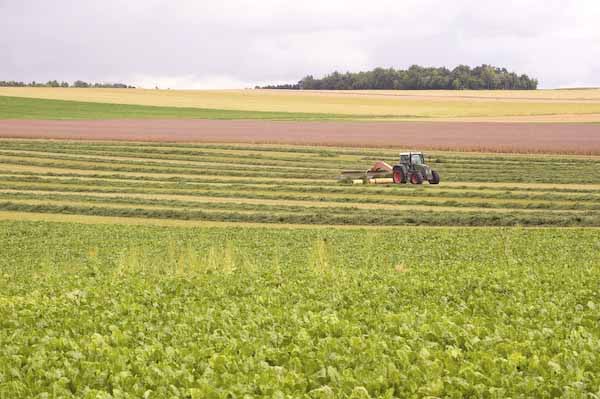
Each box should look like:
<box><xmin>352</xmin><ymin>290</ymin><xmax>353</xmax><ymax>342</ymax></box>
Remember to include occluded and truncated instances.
<box><xmin>0</xmin><ymin>140</ymin><xmax>600</xmax><ymax>226</ymax></box>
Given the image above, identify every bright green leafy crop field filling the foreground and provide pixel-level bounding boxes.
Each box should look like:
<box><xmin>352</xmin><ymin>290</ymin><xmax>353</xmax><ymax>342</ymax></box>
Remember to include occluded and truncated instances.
<box><xmin>0</xmin><ymin>222</ymin><xmax>600</xmax><ymax>398</ymax></box>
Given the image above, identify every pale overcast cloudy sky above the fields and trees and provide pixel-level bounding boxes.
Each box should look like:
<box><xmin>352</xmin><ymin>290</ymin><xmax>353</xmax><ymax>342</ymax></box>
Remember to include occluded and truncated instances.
<box><xmin>0</xmin><ymin>0</ymin><xmax>600</xmax><ymax>89</ymax></box>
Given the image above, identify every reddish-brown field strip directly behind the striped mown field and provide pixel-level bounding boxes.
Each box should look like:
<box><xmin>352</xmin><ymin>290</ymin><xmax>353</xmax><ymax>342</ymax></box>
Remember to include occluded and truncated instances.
<box><xmin>0</xmin><ymin>119</ymin><xmax>600</xmax><ymax>155</ymax></box>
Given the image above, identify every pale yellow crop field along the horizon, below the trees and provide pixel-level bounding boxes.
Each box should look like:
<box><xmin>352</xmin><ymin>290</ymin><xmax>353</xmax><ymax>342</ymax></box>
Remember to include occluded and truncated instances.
<box><xmin>0</xmin><ymin>87</ymin><xmax>600</xmax><ymax>122</ymax></box>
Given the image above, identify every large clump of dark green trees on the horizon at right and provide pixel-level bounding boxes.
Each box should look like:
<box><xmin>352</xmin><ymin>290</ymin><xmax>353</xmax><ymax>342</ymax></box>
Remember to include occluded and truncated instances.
<box><xmin>256</xmin><ymin>64</ymin><xmax>538</xmax><ymax>90</ymax></box>
